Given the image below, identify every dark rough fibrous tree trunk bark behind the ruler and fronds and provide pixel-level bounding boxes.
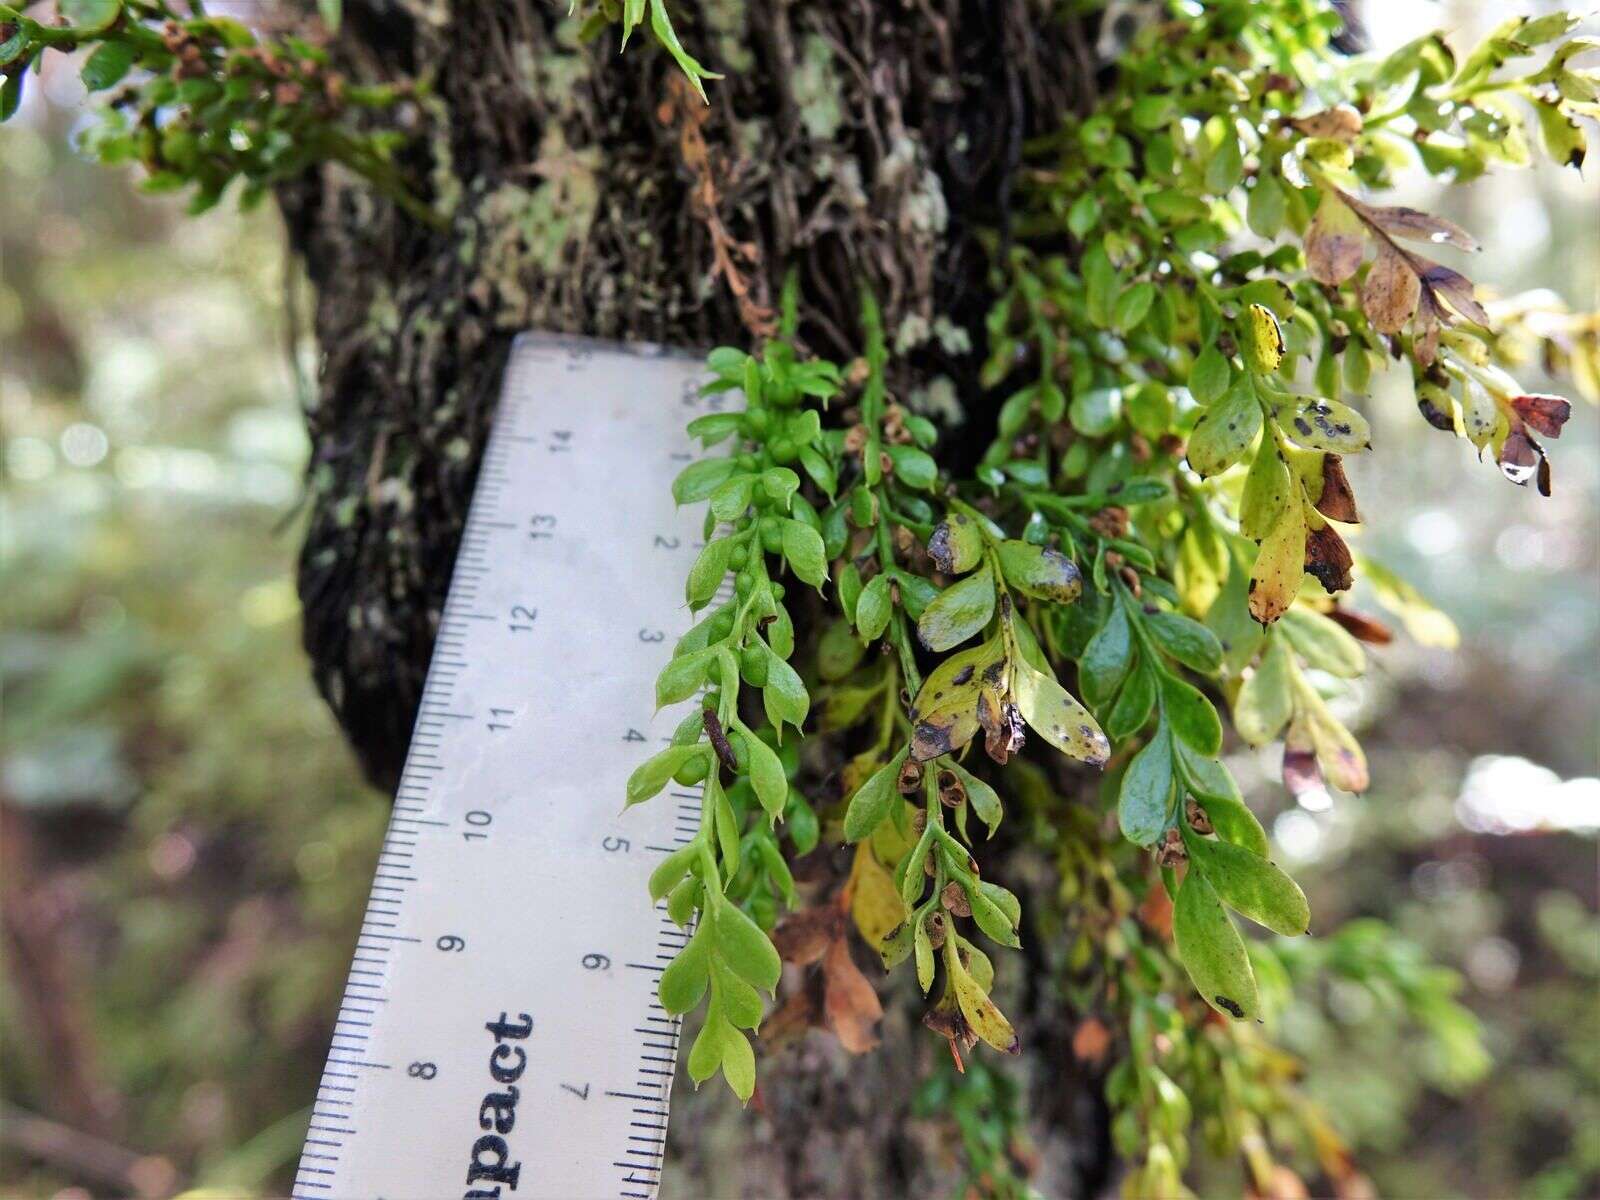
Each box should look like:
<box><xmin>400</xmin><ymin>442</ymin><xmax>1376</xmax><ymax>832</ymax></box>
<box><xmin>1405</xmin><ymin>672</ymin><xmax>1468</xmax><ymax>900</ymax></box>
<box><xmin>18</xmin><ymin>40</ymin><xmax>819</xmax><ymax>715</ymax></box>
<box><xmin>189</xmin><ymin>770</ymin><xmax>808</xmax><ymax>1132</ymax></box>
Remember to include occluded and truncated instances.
<box><xmin>282</xmin><ymin>0</ymin><xmax>1110</xmax><ymax>1197</ymax></box>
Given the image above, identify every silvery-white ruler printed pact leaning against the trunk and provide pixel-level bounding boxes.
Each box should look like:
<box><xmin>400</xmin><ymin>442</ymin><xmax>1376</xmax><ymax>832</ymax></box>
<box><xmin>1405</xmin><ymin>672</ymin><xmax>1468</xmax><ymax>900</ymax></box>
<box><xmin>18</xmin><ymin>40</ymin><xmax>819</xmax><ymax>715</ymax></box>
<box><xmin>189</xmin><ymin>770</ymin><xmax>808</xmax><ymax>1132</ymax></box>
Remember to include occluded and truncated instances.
<box><xmin>293</xmin><ymin>334</ymin><xmax>726</xmax><ymax>1200</ymax></box>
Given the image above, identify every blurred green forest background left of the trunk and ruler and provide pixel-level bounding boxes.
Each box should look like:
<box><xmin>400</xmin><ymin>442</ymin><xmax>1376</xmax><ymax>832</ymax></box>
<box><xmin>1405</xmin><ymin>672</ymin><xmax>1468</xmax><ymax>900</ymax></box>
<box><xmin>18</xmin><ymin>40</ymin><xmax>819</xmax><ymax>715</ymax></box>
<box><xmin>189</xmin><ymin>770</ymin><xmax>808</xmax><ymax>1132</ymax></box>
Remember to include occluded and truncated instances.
<box><xmin>0</xmin><ymin>80</ymin><xmax>387</xmax><ymax>1194</ymax></box>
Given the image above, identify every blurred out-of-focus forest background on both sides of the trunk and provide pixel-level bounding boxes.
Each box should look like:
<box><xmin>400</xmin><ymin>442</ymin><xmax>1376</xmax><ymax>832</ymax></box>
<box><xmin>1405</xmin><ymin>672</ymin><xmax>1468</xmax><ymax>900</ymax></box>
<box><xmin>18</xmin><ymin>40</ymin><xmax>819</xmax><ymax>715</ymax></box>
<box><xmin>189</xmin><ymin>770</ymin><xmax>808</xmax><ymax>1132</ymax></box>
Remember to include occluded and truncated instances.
<box><xmin>0</xmin><ymin>3</ymin><xmax>1600</xmax><ymax>1200</ymax></box>
